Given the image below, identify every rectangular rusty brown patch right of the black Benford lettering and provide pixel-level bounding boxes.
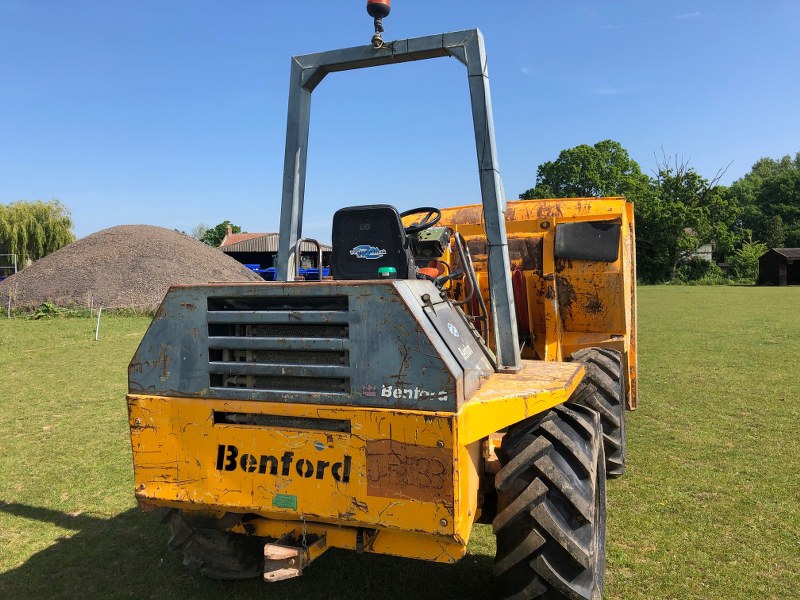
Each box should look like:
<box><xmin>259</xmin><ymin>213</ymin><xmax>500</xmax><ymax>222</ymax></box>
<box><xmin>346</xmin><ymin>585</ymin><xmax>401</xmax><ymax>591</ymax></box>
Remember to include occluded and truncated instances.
<box><xmin>366</xmin><ymin>440</ymin><xmax>453</xmax><ymax>504</ymax></box>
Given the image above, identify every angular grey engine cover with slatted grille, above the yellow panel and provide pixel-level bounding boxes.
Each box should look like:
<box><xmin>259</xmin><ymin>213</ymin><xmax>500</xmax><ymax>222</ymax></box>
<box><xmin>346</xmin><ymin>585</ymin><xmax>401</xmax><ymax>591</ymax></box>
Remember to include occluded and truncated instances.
<box><xmin>128</xmin><ymin>281</ymin><xmax>494</xmax><ymax>411</ymax></box>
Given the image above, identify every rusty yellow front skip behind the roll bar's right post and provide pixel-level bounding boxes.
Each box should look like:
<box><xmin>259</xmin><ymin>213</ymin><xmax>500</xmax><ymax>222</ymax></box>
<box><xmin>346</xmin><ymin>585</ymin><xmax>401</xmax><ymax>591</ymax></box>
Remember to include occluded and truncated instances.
<box><xmin>440</xmin><ymin>198</ymin><xmax>638</xmax><ymax>409</ymax></box>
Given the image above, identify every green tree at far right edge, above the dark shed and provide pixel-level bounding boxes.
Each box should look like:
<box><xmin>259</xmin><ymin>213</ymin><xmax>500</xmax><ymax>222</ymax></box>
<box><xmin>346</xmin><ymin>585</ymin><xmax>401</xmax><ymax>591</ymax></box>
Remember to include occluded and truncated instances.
<box><xmin>729</xmin><ymin>152</ymin><xmax>800</xmax><ymax>247</ymax></box>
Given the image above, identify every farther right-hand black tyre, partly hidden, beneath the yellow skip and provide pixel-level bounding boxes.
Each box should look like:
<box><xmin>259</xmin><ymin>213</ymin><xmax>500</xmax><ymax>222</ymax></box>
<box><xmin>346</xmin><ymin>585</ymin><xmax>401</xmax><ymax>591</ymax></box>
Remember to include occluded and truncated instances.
<box><xmin>570</xmin><ymin>348</ymin><xmax>626</xmax><ymax>478</ymax></box>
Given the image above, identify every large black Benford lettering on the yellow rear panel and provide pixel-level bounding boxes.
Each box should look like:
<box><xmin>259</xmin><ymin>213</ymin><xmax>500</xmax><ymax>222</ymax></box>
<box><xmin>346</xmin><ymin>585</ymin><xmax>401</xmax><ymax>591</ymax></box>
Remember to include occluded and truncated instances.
<box><xmin>217</xmin><ymin>444</ymin><xmax>353</xmax><ymax>483</ymax></box>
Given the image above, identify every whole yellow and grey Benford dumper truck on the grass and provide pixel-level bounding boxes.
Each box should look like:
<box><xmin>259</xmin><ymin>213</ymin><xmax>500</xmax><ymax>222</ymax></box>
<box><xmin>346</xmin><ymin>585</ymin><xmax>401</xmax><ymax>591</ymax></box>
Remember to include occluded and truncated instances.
<box><xmin>127</xmin><ymin>24</ymin><xmax>637</xmax><ymax>598</ymax></box>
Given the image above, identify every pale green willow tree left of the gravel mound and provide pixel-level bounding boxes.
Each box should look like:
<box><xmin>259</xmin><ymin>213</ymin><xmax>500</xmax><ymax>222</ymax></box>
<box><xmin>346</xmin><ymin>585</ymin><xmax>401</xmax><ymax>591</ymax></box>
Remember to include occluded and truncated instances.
<box><xmin>0</xmin><ymin>200</ymin><xmax>75</xmax><ymax>265</ymax></box>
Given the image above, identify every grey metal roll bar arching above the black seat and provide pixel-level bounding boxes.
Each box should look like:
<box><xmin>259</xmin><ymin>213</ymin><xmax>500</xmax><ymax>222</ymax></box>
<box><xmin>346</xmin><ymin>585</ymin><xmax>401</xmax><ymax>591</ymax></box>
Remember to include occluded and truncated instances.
<box><xmin>277</xmin><ymin>29</ymin><xmax>522</xmax><ymax>371</ymax></box>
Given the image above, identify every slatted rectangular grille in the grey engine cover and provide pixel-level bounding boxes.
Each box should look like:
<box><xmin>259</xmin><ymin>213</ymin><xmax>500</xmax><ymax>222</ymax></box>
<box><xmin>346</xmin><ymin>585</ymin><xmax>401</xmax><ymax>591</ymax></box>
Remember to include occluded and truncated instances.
<box><xmin>207</xmin><ymin>296</ymin><xmax>351</xmax><ymax>396</ymax></box>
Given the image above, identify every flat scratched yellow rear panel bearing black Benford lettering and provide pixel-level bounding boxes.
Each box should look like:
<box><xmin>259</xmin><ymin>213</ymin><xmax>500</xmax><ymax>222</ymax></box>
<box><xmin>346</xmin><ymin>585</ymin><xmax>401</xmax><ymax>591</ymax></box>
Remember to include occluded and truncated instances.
<box><xmin>128</xmin><ymin>395</ymin><xmax>457</xmax><ymax>536</ymax></box>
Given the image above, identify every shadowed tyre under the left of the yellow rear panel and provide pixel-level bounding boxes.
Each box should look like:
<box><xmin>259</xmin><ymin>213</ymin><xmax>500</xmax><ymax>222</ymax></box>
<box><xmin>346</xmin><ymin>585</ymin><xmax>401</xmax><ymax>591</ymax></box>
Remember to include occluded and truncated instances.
<box><xmin>163</xmin><ymin>508</ymin><xmax>264</xmax><ymax>579</ymax></box>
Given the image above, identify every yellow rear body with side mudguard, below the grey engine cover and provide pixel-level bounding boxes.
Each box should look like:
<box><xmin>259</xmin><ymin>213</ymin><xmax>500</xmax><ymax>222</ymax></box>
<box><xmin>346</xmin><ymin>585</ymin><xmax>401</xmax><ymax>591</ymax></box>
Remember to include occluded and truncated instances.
<box><xmin>128</xmin><ymin>361</ymin><xmax>583</xmax><ymax>562</ymax></box>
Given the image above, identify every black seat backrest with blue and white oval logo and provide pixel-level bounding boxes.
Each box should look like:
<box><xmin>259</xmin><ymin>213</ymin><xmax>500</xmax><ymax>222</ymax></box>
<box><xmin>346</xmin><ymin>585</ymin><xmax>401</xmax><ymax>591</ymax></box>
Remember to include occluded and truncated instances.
<box><xmin>331</xmin><ymin>204</ymin><xmax>416</xmax><ymax>279</ymax></box>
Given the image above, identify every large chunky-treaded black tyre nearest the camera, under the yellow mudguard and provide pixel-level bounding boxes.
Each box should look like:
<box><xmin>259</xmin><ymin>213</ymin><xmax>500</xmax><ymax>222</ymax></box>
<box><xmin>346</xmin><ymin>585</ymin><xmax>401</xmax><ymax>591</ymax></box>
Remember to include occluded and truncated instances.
<box><xmin>493</xmin><ymin>405</ymin><xmax>606</xmax><ymax>600</ymax></box>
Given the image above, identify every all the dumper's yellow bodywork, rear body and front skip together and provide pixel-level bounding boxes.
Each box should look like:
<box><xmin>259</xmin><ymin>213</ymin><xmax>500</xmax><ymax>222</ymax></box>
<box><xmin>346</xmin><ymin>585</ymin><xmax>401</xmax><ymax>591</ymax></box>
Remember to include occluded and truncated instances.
<box><xmin>128</xmin><ymin>198</ymin><xmax>637</xmax><ymax>570</ymax></box>
